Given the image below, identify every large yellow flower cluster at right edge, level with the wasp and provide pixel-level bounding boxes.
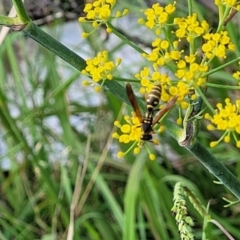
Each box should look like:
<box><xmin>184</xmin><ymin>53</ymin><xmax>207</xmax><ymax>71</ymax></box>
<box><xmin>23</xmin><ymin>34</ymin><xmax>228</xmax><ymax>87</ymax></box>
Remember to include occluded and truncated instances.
<box><xmin>205</xmin><ymin>98</ymin><xmax>240</xmax><ymax>148</ymax></box>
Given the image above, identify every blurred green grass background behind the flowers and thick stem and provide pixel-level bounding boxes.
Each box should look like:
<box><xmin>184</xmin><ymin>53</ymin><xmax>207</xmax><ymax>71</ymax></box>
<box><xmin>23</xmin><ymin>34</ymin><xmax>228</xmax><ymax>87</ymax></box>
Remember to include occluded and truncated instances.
<box><xmin>0</xmin><ymin>1</ymin><xmax>240</xmax><ymax>240</ymax></box>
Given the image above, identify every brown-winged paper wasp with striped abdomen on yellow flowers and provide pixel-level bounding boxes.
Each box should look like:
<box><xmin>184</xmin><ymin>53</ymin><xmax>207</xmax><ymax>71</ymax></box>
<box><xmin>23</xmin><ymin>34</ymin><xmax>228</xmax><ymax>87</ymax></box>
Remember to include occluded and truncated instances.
<box><xmin>126</xmin><ymin>83</ymin><xmax>177</xmax><ymax>142</ymax></box>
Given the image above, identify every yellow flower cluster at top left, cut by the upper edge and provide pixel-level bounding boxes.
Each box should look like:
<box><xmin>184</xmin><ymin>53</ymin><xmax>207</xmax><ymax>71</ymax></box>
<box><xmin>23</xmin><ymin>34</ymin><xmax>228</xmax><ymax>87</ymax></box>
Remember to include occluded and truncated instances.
<box><xmin>78</xmin><ymin>0</ymin><xmax>129</xmax><ymax>38</ymax></box>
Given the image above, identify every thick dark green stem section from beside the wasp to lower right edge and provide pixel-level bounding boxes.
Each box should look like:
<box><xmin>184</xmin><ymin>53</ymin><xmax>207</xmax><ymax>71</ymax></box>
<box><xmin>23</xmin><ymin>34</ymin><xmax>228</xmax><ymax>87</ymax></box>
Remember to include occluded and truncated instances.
<box><xmin>163</xmin><ymin>119</ymin><xmax>240</xmax><ymax>199</ymax></box>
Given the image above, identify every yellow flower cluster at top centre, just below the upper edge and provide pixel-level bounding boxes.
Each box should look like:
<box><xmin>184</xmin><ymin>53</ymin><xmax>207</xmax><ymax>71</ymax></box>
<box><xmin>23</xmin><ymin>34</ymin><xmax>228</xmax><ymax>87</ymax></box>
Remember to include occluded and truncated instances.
<box><xmin>138</xmin><ymin>2</ymin><xmax>176</xmax><ymax>34</ymax></box>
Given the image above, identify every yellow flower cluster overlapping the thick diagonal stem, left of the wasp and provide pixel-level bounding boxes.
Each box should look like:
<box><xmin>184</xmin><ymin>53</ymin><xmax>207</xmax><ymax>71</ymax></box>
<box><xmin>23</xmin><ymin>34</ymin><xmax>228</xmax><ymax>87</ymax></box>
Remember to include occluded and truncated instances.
<box><xmin>82</xmin><ymin>50</ymin><xmax>121</xmax><ymax>91</ymax></box>
